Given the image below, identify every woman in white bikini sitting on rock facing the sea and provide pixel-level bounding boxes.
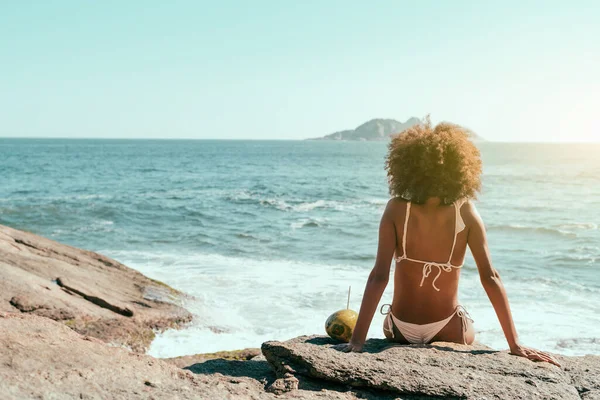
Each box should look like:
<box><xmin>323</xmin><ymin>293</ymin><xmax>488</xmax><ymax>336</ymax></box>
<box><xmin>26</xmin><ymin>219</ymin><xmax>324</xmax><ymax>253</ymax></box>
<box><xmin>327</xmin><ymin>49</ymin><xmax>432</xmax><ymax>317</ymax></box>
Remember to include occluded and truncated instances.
<box><xmin>341</xmin><ymin>120</ymin><xmax>559</xmax><ymax>365</ymax></box>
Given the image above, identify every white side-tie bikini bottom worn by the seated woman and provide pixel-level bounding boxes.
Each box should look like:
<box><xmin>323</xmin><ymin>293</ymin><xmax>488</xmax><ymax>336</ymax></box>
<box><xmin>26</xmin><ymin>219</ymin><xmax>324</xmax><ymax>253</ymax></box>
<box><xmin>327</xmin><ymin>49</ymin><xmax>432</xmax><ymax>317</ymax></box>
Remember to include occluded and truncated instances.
<box><xmin>380</xmin><ymin>304</ymin><xmax>473</xmax><ymax>344</ymax></box>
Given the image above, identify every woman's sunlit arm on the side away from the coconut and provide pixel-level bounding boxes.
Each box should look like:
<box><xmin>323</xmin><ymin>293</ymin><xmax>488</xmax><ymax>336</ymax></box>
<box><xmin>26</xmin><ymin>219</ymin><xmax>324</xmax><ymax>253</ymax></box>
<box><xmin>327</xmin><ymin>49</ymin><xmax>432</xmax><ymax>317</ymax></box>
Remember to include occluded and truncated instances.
<box><xmin>464</xmin><ymin>202</ymin><xmax>560</xmax><ymax>366</ymax></box>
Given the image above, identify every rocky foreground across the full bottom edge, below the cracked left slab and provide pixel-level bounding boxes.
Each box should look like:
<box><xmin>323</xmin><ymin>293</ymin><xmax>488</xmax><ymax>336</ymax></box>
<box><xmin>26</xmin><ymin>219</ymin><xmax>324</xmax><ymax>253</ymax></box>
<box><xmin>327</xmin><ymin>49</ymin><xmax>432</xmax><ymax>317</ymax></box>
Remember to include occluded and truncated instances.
<box><xmin>0</xmin><ymin>312</ymin><xmax>600</xmax><ymax>400</ymax></box>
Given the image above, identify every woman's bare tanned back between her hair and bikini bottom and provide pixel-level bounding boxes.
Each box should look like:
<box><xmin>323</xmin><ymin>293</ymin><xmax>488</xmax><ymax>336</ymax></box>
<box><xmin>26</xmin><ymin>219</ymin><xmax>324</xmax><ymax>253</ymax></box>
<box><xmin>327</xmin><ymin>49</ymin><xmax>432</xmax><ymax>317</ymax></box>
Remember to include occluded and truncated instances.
<box><xmin>390</xmin><ymin>199</ymin><xmax>469</xmax><ymax>324</ymax></box>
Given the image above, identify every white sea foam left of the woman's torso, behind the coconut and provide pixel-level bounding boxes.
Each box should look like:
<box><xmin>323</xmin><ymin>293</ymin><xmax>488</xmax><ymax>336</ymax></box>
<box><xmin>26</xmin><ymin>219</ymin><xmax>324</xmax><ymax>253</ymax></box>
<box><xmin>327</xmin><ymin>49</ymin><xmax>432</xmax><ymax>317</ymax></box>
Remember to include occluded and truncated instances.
<box><xmin>104</xmin><ymin>251</ymin><xmax>391</xmax><ymax>357</ymax></box>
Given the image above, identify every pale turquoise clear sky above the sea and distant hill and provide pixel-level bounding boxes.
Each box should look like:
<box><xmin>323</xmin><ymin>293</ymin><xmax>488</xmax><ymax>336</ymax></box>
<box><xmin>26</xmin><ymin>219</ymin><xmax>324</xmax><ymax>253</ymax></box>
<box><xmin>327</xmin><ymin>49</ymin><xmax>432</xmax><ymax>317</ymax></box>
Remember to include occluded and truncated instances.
<box><xmin>0</xmin><ymin>0</ymin><xmax>600</xmax><ymax>142</ymax></box>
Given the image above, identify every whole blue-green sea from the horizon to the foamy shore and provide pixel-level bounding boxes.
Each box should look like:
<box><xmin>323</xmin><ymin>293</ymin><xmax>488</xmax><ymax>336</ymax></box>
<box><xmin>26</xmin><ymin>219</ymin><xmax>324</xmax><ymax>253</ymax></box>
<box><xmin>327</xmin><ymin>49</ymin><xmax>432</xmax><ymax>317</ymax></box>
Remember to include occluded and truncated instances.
<box><xmin>0</xmin><ymin>139</ymin><xmax>600</xmax><ymax>357</ymax></box>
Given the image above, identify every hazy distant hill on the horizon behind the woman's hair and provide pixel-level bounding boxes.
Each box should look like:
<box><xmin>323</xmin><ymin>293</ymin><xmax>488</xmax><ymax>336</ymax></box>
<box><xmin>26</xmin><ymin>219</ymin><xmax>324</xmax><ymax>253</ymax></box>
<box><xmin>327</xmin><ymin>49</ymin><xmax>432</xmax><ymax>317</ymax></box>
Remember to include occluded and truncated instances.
<box><xmin>309</xmin><ymin>117</ymin><xmax>483</xmax><ymax>141</ymax></box>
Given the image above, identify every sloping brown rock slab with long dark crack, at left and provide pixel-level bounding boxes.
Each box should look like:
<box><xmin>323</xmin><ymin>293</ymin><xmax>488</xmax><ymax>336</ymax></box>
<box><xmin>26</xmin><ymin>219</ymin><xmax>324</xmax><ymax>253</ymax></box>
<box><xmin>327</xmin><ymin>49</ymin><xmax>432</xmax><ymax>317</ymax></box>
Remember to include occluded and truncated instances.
<box><xmin>0</xmin><ymin>225</ymin><xmax>191</xmax><ymax>352</ymax></box>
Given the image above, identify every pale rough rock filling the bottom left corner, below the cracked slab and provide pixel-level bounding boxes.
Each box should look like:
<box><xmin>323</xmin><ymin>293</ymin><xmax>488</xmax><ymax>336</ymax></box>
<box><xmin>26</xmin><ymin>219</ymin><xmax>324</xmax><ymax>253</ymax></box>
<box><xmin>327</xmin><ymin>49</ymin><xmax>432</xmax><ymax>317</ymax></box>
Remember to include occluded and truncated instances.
<box><xmin>0</xmin><ymin>312</ymin><xmax>375</xmax><ymax>400</ymax></box>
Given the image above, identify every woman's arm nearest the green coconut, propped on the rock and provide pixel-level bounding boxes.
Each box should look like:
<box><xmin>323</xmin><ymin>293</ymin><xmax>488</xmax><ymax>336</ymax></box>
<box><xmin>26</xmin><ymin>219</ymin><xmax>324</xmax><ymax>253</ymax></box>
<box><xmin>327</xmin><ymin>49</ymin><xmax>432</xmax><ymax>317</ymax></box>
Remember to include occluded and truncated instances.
<box><xmin>340</xmin><ymin>199</ymin><xmax>396</xmax><ymax>352</ymax></box>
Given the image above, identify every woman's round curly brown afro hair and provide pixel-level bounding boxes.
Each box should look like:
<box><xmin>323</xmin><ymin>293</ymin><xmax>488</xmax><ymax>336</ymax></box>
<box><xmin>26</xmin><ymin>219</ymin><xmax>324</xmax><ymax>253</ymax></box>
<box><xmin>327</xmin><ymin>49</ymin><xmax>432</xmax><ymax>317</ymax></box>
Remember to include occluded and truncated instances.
<box><xmin>385</xmin><ymin>117</ymin><xmax>481</xmax><ymax>204</ymax></box>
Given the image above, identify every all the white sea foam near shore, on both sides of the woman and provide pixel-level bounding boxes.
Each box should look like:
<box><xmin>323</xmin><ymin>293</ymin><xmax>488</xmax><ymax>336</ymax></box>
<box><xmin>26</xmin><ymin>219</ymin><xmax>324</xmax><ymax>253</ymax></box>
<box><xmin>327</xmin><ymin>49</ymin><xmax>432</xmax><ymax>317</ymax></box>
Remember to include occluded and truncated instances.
<box><xmin>99</xmin><ymin>251</ymin><xmax>600</xmax><ymax>357</ymax></box>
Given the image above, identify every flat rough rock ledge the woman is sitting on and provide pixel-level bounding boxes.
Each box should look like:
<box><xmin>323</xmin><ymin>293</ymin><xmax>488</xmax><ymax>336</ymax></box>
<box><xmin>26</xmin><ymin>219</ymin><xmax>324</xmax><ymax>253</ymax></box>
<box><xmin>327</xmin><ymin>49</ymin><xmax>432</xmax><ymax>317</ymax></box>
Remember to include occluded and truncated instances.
<box><xmin>262</xmin><ymin>336</ymin><xmax>600</xmax><ymax>400</ymax></box>
